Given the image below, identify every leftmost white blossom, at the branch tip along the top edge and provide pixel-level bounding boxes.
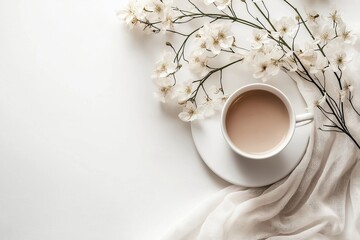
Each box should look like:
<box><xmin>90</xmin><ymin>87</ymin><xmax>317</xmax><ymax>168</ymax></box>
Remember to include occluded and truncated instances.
<box><xmin>117</xmin><ymin>0</ymin><xmax>145</xmax><ymax>28</ymax></box>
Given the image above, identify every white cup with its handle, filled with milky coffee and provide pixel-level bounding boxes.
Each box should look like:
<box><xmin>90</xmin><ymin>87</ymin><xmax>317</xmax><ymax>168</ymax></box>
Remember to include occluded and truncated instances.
<box><xmin>222</xmin><ymin>83</ymin><xmax>313</xmax><ymax>159</ymax></box>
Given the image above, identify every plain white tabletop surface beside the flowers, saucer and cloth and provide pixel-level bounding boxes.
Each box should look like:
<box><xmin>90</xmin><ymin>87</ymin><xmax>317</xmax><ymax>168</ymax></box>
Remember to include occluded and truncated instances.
<box><xmin>0</xmin><ymin>0</ymin><xmax>358</xmax><ymax>240</ymax></box>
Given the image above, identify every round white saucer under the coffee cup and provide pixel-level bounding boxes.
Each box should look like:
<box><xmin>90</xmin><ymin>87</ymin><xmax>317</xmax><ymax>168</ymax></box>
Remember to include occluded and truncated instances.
<box><xmin>191</xmin><ymin>77</ymin><xmax>312</xmax><ymax>187</ymax></box>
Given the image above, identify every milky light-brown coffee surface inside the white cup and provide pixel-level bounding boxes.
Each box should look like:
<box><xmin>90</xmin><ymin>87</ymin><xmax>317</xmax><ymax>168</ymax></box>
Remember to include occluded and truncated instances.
<box><xmin>225</xmin><ymin>90</ymin><xmax>290</xmax><ymax>154</ymax></box>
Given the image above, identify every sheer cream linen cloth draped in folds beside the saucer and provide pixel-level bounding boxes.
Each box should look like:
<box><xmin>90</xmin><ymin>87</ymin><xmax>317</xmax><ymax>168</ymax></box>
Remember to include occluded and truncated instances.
<box><xmin>162</xmin><ymin>59</ymin><xmax>360</xmax><ymax>240</ymax></box>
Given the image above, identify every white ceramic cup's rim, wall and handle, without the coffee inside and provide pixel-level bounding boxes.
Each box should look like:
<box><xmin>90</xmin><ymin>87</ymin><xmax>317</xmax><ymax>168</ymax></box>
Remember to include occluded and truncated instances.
<box><xmin>221</xmin><ymin>83</ymin><xmax>314</xmax><ymax>160</ymax></box>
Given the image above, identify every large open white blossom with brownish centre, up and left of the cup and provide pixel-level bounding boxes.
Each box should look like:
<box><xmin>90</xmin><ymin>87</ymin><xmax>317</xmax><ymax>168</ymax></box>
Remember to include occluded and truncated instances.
<box><xmin>203</xmin><ymin>23</ymin><xmax>234</xmax><ymax>55</ymax></box>
